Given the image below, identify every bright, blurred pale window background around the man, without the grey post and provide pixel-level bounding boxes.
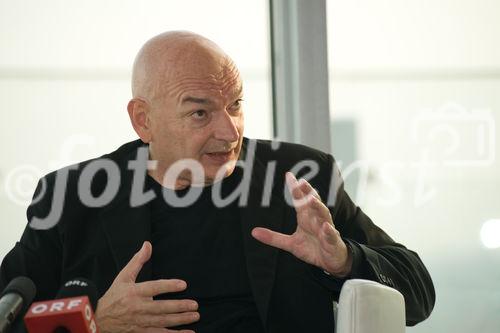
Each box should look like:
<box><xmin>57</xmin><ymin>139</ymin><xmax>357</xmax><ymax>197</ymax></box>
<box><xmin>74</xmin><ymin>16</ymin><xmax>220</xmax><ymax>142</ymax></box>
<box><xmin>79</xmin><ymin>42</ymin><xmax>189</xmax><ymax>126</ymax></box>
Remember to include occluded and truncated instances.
<box><xmin>0</xmin><ymin>0</ymin><xmax>500</xmax><ymax>333</ymax></box>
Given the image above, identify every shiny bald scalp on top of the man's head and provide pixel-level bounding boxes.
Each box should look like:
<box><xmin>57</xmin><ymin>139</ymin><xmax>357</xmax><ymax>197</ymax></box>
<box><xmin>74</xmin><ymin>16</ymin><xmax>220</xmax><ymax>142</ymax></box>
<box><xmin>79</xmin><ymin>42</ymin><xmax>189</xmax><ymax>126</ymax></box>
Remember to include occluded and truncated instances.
<box><xmin>132</xmin><ymin>31</ymin><xmax>235</xmax><ymax>102</ymax></box>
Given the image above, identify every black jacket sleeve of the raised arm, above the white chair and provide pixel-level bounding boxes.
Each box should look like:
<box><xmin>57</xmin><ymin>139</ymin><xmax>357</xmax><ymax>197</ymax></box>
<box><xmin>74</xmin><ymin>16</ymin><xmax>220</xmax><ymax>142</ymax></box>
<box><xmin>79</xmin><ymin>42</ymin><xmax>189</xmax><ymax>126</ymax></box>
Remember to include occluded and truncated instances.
<box><xmin>319</xmin><ymin>155</ymin><xmax>435</xmax><ymax>326</ymax></box>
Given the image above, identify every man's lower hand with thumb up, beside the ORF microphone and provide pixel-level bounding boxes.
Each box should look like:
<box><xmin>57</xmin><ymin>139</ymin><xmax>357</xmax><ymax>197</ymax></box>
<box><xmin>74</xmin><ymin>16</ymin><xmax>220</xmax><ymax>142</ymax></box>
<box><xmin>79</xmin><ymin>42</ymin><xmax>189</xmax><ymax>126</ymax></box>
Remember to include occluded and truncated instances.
<box><xmin>95</xmin><ymin>242</ymin><xmax>200</xmax><ymax>333</ymax></box>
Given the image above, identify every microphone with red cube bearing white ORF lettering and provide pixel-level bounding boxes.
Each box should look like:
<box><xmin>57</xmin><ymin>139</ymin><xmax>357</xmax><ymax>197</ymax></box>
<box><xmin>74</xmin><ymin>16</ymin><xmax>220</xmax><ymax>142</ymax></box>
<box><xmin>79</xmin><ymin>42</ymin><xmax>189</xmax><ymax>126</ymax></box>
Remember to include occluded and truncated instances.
<box><xmin>24</xmin><ymin>278</ymin><xmax>98</xmax><ymax>333</ymax></box>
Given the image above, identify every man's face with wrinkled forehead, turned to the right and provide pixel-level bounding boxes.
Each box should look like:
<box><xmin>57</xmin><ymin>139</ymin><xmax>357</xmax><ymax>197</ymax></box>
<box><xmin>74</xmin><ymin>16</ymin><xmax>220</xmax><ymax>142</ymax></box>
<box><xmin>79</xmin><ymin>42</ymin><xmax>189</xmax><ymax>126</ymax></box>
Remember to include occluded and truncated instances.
<box><xmin>146</xmin><ymin>50</ymin><xmax>243</xmax><ymax>183</ymax></box>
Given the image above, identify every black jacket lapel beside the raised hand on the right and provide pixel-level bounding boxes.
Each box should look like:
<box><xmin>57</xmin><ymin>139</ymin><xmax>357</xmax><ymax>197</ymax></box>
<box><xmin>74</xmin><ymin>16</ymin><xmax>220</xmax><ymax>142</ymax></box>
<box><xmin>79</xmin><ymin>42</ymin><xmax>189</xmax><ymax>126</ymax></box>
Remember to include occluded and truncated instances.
<box><xmin>241</xmin><ymin>140</ymin><xmax>284</xmax><ymax>323</ymax></box>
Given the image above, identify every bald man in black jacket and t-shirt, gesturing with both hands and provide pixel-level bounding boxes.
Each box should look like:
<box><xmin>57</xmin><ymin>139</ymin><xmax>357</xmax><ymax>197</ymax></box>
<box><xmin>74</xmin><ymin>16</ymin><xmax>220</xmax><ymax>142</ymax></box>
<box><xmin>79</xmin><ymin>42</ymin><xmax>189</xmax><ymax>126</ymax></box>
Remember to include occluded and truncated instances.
<box><xmin>0</xmin><ymin>32</ymin><xmax>435</xmax><ymax>333</ymax></box>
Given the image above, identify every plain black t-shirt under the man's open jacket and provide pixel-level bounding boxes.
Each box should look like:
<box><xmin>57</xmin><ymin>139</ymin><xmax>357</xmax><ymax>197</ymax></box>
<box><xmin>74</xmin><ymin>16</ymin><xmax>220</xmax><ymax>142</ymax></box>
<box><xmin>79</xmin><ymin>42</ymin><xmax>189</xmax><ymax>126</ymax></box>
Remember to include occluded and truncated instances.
<box><xmin>148</xmin><ymin>170</ymin><xmax>264</xmax><ymax>333</ymax></box>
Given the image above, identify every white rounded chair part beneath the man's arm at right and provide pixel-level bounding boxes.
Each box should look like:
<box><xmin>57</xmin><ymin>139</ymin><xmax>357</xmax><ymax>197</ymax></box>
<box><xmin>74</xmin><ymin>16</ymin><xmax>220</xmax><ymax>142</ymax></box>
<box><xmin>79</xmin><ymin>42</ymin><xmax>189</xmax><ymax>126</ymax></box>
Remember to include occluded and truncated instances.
<box><xmin>334</xmin><ymin>279</ymin><xmax>406</xmax><ymax>333</ymax></box>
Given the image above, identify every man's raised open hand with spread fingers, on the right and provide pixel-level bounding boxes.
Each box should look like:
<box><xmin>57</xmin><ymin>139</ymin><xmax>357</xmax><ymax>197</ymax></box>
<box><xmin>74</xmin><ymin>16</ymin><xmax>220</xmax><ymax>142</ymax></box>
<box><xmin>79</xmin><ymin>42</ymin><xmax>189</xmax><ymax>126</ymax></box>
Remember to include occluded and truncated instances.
<box><xmin>252</xmin><ymin>172</ymin><xmax>352</xmax><ymax>277</ymax></box>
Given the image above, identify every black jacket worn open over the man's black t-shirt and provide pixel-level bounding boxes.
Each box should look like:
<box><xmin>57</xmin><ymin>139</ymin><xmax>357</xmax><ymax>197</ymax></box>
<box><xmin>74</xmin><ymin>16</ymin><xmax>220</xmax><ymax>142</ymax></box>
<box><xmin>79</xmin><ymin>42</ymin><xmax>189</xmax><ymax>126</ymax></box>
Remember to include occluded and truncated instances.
<box><xmin>0</xmin><ymin>139</ymin><xmax>435</xmax><ymax>332</ymax></box>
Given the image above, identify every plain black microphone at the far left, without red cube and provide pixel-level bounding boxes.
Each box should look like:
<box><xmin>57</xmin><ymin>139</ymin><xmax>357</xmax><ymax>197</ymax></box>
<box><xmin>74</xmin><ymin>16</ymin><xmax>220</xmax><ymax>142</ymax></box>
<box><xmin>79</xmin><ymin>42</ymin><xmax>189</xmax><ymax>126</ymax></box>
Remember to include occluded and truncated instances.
<box><xmin>0</xmin><ymin>276</ymin><xmax>36</xmax><ymax>333</ymax></box>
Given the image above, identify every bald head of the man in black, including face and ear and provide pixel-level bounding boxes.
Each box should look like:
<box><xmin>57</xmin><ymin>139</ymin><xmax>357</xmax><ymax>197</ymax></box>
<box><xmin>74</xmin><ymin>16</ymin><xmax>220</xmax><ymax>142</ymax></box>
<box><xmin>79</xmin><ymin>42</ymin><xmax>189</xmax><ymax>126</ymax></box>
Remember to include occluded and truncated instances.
<box><xmin>128</xmin><ymin>31</ymin><xmax>243</xmax><ymax>187</ymax></box>
